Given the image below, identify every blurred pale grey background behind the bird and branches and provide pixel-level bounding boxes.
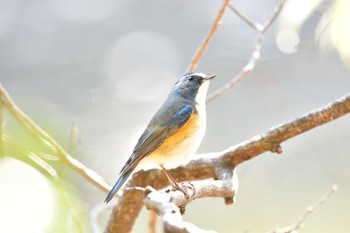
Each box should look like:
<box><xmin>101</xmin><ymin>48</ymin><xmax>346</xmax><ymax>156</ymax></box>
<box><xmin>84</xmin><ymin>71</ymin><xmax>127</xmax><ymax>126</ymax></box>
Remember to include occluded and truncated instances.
<box><xmin>0</xmin><ymin>0</ymin><xmax>350</xmax><ymax>233</ymax></box>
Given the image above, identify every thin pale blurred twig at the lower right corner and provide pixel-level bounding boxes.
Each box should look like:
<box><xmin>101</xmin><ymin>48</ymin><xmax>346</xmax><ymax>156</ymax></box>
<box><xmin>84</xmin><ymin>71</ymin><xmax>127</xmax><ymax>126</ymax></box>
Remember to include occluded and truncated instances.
<box><xmin>267</xmin><ymin>184</ymin><xmax>338</xmax><ymax>233</ymax></box>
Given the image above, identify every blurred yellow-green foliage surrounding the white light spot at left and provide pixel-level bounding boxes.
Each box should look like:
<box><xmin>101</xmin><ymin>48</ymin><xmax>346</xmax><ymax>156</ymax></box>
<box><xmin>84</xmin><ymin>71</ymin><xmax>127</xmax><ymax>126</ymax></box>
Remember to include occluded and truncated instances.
<box><xmin>0</xmin><ymin>86</ymin><xmax>90</xmax><ymax>233</ymax></box>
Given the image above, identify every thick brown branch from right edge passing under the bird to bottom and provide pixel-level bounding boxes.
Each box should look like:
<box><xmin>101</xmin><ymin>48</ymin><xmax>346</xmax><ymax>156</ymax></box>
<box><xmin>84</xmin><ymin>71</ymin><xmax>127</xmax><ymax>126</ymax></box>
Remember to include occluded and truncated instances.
<box><xmin>106</xmin><ymin>93</ymin><xmax>350</xmax><ymax>233</ymax></box>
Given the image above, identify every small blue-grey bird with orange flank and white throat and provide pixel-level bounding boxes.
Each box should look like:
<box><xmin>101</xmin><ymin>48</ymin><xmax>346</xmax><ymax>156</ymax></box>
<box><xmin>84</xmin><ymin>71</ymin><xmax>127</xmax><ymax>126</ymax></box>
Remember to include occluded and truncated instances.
<box><xmin>105</xmin><ymin>72</ymin><xmax>216</xmax><ymax>203</ymax></box>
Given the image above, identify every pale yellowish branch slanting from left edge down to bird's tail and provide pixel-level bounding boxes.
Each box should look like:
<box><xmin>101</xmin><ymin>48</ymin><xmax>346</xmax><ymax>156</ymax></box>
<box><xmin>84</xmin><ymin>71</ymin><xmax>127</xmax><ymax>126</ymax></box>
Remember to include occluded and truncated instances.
<box><xmin>0</xmin><ymin>84</ymin><xmax>110</xmax><ymax>192</ymax></box>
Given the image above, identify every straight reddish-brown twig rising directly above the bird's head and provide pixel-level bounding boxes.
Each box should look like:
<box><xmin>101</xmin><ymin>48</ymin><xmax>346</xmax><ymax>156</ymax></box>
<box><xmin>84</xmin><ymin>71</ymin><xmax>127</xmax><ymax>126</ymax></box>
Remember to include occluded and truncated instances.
<box><xmin>187</xmin><ymin>0</ymin><xmax>230</xmax><ymax>71</ymax></box>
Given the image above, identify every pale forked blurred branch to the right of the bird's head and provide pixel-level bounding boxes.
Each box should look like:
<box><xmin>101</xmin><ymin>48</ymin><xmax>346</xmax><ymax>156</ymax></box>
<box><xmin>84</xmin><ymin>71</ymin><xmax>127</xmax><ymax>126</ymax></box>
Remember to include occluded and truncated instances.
<box><xmin>207</xmin><ymin>0</ymin><xmax>288</xmax><ymax>103</ymax></box>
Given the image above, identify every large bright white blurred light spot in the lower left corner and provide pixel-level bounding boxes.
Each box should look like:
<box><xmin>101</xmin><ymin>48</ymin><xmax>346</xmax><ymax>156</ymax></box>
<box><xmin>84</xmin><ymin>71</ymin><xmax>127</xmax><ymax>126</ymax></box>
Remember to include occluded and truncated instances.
<box><xmin>0</xmin><ymin>158</ymin><xmax>55</xmax><ymax>233</ymax></box>
